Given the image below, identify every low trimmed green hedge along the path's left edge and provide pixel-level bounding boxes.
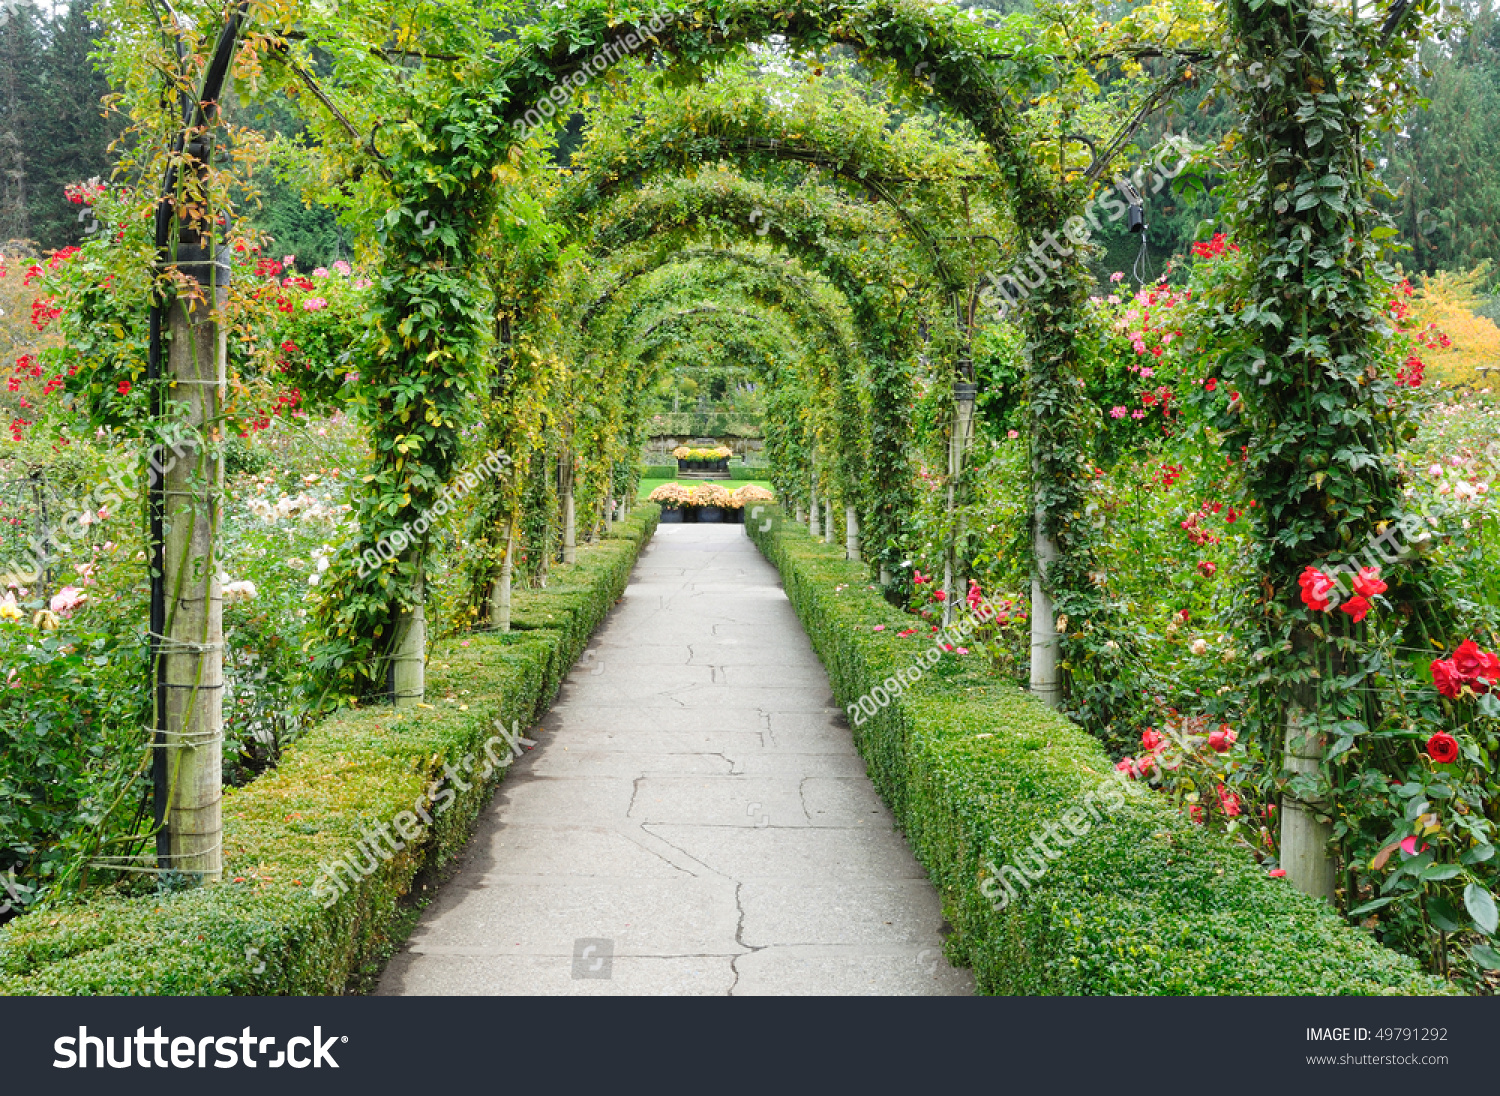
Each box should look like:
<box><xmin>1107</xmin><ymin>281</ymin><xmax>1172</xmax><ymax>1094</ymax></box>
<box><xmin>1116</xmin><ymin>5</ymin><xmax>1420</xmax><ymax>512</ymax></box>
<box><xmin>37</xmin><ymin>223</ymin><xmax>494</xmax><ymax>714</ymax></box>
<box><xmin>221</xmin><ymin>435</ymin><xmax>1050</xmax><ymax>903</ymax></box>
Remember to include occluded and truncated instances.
<box><xmin>0</xmin><ymin>504</ymin><xmax>660</xmax><ymax>996</ymax></box>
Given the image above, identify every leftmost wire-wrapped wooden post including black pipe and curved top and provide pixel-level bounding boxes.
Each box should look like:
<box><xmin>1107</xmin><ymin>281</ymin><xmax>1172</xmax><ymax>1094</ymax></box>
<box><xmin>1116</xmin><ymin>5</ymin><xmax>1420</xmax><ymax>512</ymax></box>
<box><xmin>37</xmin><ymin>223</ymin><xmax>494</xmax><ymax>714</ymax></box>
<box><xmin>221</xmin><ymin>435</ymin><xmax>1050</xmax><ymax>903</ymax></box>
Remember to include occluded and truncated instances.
<box><xmin>146</xmin><ymin>0</ymin><xmax>249</xmax><ymax>880</ymax></box>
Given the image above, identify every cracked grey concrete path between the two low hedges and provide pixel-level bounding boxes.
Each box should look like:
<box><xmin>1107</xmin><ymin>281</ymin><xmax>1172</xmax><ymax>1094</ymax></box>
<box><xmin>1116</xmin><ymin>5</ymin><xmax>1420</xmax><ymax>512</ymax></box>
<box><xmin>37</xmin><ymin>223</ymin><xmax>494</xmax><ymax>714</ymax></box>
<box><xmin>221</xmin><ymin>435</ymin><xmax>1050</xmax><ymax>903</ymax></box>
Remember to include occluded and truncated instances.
<box><xmin>378</xmin><ymin>525</ymin><xmax>974</xmax><ymax>996</ymax></box>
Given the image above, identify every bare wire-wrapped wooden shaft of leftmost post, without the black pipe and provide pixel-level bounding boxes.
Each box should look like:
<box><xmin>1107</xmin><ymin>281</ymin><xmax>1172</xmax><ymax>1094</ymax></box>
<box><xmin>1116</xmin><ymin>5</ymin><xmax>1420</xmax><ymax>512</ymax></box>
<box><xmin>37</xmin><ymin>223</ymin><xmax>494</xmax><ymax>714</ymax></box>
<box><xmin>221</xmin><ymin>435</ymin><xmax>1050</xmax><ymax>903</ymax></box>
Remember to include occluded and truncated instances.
<box><xmin>158</xmin><ymin>260</ymin><xmax>230</xmax><ymax>880</ymax></box>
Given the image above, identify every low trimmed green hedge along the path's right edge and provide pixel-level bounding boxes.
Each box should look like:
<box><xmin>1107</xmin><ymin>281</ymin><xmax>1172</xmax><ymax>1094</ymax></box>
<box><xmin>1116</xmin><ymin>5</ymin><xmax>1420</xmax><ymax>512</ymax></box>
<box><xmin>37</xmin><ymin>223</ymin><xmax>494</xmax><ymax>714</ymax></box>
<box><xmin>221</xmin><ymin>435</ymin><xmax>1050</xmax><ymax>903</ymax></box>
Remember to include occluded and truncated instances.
<box><xmin>746</xmin><ymin>510</ymin><xmax>1449</xmax><ymax>996</ymax></box>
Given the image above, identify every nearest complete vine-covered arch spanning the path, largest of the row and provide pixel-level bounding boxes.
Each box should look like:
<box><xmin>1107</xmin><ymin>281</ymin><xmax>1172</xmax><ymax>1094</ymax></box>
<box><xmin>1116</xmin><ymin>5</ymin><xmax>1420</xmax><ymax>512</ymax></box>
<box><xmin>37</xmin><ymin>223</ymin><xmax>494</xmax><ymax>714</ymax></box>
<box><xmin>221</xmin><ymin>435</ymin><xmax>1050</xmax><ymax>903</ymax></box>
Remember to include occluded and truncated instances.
<box><xmin>321</xmin><ymin>0</ymin><xmax>1104</xmax><ymax>702</ymax></box>
